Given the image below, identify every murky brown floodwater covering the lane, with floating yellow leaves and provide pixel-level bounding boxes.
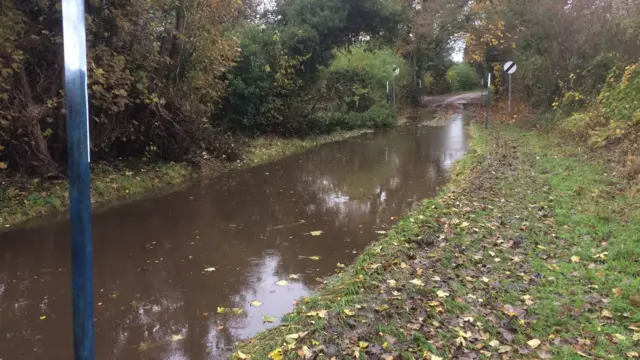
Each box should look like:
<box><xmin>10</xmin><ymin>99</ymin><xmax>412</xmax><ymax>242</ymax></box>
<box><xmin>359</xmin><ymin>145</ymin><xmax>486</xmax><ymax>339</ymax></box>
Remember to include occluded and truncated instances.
<box><xmin>0</xmin><ymin>115</ymin><xmax>467</xmax><ymax>360</ymax></box>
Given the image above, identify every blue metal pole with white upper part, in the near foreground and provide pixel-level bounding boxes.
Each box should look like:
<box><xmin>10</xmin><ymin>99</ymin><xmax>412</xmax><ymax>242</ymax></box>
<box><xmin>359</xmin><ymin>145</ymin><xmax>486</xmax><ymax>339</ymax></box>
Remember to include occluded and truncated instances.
<box><xmin>62</xmin><ymin>0</ymin><xmax>94</xmax><ymax>360</ymax></box>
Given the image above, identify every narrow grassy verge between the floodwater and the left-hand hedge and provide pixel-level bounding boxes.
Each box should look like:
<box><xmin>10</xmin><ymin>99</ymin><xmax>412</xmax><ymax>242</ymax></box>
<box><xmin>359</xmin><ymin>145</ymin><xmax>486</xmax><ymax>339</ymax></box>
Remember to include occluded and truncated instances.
<box><xmin>0</xmin><ymin>130</ymin><xmax>368</xmax><ymax>228</ymax></box>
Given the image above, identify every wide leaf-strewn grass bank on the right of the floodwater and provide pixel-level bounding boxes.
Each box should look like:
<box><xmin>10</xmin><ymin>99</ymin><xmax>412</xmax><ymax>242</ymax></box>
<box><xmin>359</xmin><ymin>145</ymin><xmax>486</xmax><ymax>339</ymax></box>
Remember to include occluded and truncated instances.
<box><xmin>232</xmin><ymin>126</ymin><xmax>640</xmax><ymax>360</ymax></box>
